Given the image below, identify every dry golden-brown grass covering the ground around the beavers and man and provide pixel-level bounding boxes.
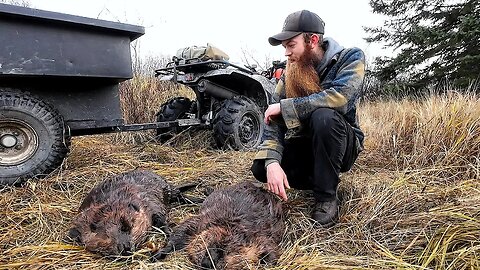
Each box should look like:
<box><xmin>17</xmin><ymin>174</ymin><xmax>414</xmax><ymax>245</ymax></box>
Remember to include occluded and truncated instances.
<box><xmin>0</xmin><ymin>80</ymin><xmax>480</xmax><ymax>270</ymax></box>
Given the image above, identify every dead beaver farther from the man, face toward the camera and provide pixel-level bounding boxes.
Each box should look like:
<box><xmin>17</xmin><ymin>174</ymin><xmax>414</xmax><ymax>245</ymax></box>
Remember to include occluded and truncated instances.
<box><xmin>67</xmin><ymin>169</ymin><xmax>189</xmax><ymax>256</ymax></box>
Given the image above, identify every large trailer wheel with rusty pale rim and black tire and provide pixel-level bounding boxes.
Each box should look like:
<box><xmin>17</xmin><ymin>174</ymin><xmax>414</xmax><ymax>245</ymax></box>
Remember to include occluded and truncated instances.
<box><xmin>0</xmin><ymin>89</ymin><xmax>70</xmax><ymax>186</ymax></box>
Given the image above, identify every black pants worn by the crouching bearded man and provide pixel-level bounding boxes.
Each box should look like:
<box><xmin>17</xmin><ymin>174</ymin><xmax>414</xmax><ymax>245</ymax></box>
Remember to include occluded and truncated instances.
<box><xmin>251</xmin><ymin>108</ymin><xmax>358</xmax><ymax>201</ymax></box>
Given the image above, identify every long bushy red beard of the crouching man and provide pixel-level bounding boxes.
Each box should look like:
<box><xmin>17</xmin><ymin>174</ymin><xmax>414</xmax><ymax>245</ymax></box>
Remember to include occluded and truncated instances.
<box><xmin>285</xmin><ymin>47</ymin><xmax>322</xmax><ymax>98</ymax></box>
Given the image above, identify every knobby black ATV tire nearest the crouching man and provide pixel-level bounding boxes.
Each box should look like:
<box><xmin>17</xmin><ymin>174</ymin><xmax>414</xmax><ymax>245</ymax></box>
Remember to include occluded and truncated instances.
<box><xmin>213</xmin><ymin>96</ymin><xmax>264</xmax><ymax>150</ymax></box>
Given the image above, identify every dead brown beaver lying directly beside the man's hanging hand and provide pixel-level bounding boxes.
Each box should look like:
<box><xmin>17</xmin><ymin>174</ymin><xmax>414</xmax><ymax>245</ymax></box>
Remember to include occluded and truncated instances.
<box><xmin>153</xmin><ymin>181</ymin><xmax>285</xmax><ymax>269</ymax></box>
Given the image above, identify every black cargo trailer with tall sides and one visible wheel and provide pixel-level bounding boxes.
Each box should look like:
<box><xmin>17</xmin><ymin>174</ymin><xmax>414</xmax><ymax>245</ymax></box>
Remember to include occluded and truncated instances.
<box><xmin>0</xmin><ymin>4</ymin><xmax>150</xmax><ymax>185</ymax></box>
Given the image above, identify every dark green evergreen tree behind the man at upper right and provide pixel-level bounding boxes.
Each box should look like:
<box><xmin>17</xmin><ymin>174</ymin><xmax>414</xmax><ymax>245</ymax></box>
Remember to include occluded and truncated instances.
<box><xmin>365</xmin><ymin>0</ymin><xmax>480</xmax><ymax>88</ymax></box>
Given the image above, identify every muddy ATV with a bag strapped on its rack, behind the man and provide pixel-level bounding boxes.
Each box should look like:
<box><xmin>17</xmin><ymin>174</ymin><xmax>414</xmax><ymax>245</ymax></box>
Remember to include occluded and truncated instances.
<box><xmin>155</xmin><ymin>44</ymin><xmax>275</xmax><ymax>150</ymax></box>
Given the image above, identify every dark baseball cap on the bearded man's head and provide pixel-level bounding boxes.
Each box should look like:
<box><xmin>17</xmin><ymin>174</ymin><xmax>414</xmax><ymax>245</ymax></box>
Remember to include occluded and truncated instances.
<box><xmin>268</xmin><ymin>10</ymin><xmax>325</xmax><ymax>46</ymax></box>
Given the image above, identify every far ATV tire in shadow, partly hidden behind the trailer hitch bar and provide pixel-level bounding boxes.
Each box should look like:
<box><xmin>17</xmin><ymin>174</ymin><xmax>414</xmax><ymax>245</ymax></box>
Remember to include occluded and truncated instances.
<box><xmin>155</xmin><ymin>97</ymin><xmax>195</xmax><ymax>143</ymax></box>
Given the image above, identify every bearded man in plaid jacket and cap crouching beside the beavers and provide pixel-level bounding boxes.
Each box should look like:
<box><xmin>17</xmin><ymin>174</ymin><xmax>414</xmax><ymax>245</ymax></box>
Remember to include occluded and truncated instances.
<box><xmin>251</xmin><ymin>10</ymin><xmax>365</xmax><ymax>227</ymax></box>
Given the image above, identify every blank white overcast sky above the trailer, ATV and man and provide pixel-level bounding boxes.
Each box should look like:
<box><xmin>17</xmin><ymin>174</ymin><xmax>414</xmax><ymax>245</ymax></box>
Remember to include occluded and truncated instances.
<box><xmin>29</xmin><ymin>0</ymin><xmax>386</xmax><ymax>64</ymax></box>
